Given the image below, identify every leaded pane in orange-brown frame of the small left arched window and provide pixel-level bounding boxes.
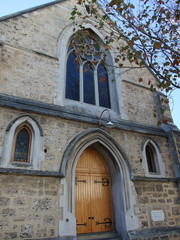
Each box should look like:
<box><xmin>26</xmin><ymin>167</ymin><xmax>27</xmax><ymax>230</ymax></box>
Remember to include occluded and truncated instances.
<box><xmin>12</xmin><ymin>126</ymin><xmax>32</xmax><ymax>163</ymax></box>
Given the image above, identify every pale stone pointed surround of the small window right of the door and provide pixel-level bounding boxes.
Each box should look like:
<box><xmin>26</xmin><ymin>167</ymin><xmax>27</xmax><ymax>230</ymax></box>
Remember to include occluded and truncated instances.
<box><xmin>141</xmin><ymin>137</ymin><xmax>166</xmax><ymax>178</ymax></box>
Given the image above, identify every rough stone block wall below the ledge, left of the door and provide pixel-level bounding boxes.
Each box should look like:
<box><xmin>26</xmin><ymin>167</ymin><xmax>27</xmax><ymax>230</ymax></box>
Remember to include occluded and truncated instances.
<box><xmin>0</xmin><ymin>174</ymin><xmax>63</xmax><ymax>240</ymax></box>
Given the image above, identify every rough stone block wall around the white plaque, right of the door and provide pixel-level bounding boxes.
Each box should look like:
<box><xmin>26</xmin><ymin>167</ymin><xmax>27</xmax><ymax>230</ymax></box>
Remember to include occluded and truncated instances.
<box><xmin>135</xmin><ymin>180</ymin><xmax>180</xmax><ymax>229</ymax></box>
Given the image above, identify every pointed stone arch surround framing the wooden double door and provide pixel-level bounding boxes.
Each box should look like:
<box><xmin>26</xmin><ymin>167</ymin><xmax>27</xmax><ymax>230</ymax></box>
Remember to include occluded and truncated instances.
<box><xmin>60</xmin><ymin>128</ymin><xmax>139</xmax><ymax>239</ymax></box>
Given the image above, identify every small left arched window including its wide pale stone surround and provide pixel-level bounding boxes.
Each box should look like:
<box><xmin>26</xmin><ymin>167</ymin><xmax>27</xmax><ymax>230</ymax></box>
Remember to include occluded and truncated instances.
<box><xmin>0</xmin><ymin>114</ymin><xmax>44</xmax><ymax>170</ymax></box>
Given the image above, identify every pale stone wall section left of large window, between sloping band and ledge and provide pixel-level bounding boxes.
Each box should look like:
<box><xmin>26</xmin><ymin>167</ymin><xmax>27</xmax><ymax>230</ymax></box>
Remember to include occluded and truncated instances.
<box><xmin>0</xmin><ymin>45</ymin><xmax>58</xmax><ymax>104</ymax></box>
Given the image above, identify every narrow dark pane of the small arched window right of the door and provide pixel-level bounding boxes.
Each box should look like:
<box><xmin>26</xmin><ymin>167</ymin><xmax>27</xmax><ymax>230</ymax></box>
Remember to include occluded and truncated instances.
<box><xmin>146</xmin><ymin>144</ymin><xmax>159</xmax><ymax>173</ymax></box>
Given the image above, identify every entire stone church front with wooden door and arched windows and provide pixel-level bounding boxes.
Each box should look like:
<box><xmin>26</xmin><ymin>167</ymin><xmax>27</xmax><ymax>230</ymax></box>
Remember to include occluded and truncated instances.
<box><xmin>0</xmin><ymin>0</ymin><xmax>180</xmax><ymax>240</ymax></box>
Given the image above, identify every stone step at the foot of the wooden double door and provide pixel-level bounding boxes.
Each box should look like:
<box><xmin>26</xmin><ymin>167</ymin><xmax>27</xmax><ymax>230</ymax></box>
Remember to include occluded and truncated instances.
<box><xmin>77</xmin><ymin>232</ymin><xmax>120</xmax><ymax>240</ymax></box>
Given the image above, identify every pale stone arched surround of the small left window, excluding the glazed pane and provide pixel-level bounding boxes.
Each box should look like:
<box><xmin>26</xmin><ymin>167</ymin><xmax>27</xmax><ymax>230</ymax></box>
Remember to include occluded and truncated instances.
<box><xmin>0</xmin><ymin>114</ymin><xmax>43</xmax><ymax>170</ymax></box>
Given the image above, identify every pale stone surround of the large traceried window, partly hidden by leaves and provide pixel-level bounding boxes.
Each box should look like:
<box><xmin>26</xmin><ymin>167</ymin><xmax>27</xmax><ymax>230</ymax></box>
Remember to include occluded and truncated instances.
<box><xmin>54</xmin><ymin>21</ymin><xmax>122</xmax><ymax>117</ymax></box>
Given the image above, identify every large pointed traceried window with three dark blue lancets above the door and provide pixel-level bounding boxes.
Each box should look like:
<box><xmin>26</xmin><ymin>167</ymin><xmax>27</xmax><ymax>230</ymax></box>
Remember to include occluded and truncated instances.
<box><xmin>65</xmin><ymin>31</ymin><xmax>111</xmax><ymax>108</ymax></box>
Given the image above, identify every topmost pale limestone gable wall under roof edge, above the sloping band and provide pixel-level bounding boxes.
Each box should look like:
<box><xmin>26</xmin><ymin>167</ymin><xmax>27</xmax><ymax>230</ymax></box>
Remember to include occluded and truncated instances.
<box><xmin>0</xmin><ymin>1</ymin><xmax>74</xmax><ymax>57</ymax></box>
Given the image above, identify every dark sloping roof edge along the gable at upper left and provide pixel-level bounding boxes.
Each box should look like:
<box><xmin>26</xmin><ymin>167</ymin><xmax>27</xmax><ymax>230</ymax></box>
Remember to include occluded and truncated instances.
<box><xmin>0</xmin><ymin>0</ymin><xmax>66</xmax><ymax>22</ymax></box>
